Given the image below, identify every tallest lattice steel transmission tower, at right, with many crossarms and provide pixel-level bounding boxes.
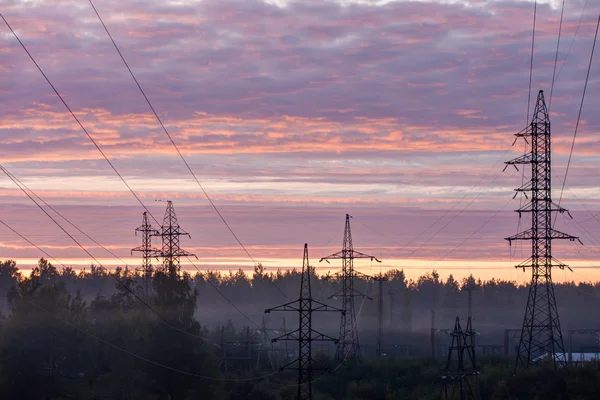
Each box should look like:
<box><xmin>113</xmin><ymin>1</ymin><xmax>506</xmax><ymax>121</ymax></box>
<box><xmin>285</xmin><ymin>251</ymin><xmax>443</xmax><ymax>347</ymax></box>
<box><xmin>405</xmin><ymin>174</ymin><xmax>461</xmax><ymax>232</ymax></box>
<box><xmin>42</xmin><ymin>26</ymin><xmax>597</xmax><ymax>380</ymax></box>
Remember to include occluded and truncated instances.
<box><xmin>505</xmin><ymin>90</ymin><xmax>579</xmax><ymax>371</ymax></box>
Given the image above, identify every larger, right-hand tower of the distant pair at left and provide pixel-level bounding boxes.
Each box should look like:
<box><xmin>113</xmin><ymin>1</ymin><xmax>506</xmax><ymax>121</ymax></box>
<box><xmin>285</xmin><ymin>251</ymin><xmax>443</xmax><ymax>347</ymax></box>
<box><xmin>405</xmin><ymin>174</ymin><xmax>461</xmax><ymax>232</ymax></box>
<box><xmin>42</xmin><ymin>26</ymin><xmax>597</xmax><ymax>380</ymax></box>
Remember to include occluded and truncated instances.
<box><xmin>157</xmin><ymin>200</ymin><xmax>198</xmax><ymax>279</ymax></box>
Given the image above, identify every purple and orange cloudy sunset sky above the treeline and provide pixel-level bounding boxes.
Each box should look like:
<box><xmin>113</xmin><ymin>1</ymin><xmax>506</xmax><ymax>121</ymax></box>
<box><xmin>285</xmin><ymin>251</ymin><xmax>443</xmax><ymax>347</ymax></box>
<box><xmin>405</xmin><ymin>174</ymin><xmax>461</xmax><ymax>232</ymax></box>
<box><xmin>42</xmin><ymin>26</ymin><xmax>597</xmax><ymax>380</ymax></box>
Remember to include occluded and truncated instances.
<box><xmin>0</xmin><ymin>0</ymin><xmax>600</xmax><ymax>283</ymax></box>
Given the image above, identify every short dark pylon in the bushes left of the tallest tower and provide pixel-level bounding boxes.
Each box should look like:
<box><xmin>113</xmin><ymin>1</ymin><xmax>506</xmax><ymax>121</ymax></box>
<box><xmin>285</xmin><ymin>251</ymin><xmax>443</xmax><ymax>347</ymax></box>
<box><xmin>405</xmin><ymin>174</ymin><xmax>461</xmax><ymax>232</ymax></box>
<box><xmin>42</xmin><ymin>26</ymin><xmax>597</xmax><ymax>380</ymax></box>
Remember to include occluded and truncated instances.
<box><xmin>440</xmin><ymin>317</ymin><xmax>479</xmax><ymax>400</ymax></box>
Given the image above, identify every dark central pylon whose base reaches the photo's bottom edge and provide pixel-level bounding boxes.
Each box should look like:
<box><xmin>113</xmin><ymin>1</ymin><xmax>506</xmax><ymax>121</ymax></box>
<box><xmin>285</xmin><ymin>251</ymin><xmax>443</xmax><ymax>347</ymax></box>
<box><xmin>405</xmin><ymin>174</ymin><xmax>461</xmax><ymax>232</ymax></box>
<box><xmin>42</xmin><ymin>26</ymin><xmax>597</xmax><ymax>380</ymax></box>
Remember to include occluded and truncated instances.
<box><xmin>265</xmin><ymin>244</ymin><xmax>343</xmax><ymax>400</ymax></box>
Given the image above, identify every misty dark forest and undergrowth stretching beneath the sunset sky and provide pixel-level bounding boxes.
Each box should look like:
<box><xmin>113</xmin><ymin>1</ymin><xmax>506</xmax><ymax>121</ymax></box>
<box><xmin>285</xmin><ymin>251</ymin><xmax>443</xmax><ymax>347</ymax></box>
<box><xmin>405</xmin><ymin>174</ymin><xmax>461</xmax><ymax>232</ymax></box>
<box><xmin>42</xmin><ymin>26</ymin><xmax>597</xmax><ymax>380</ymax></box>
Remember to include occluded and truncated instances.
<box><xmin>0</xmin><ymin>259</ymin><xmax>600</xmax><ymax>400</ymax></box>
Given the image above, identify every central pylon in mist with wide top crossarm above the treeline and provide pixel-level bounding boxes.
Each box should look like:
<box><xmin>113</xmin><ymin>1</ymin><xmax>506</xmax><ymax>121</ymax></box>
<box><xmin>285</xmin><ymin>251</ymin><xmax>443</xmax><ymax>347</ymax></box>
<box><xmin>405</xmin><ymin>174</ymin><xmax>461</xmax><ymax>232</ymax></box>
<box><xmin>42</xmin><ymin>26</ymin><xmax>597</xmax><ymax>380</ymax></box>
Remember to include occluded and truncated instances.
<box><xmin>319</xmin><ymin>214</ymin><xmax>381</xmax><ymax>361</ymax></box>
